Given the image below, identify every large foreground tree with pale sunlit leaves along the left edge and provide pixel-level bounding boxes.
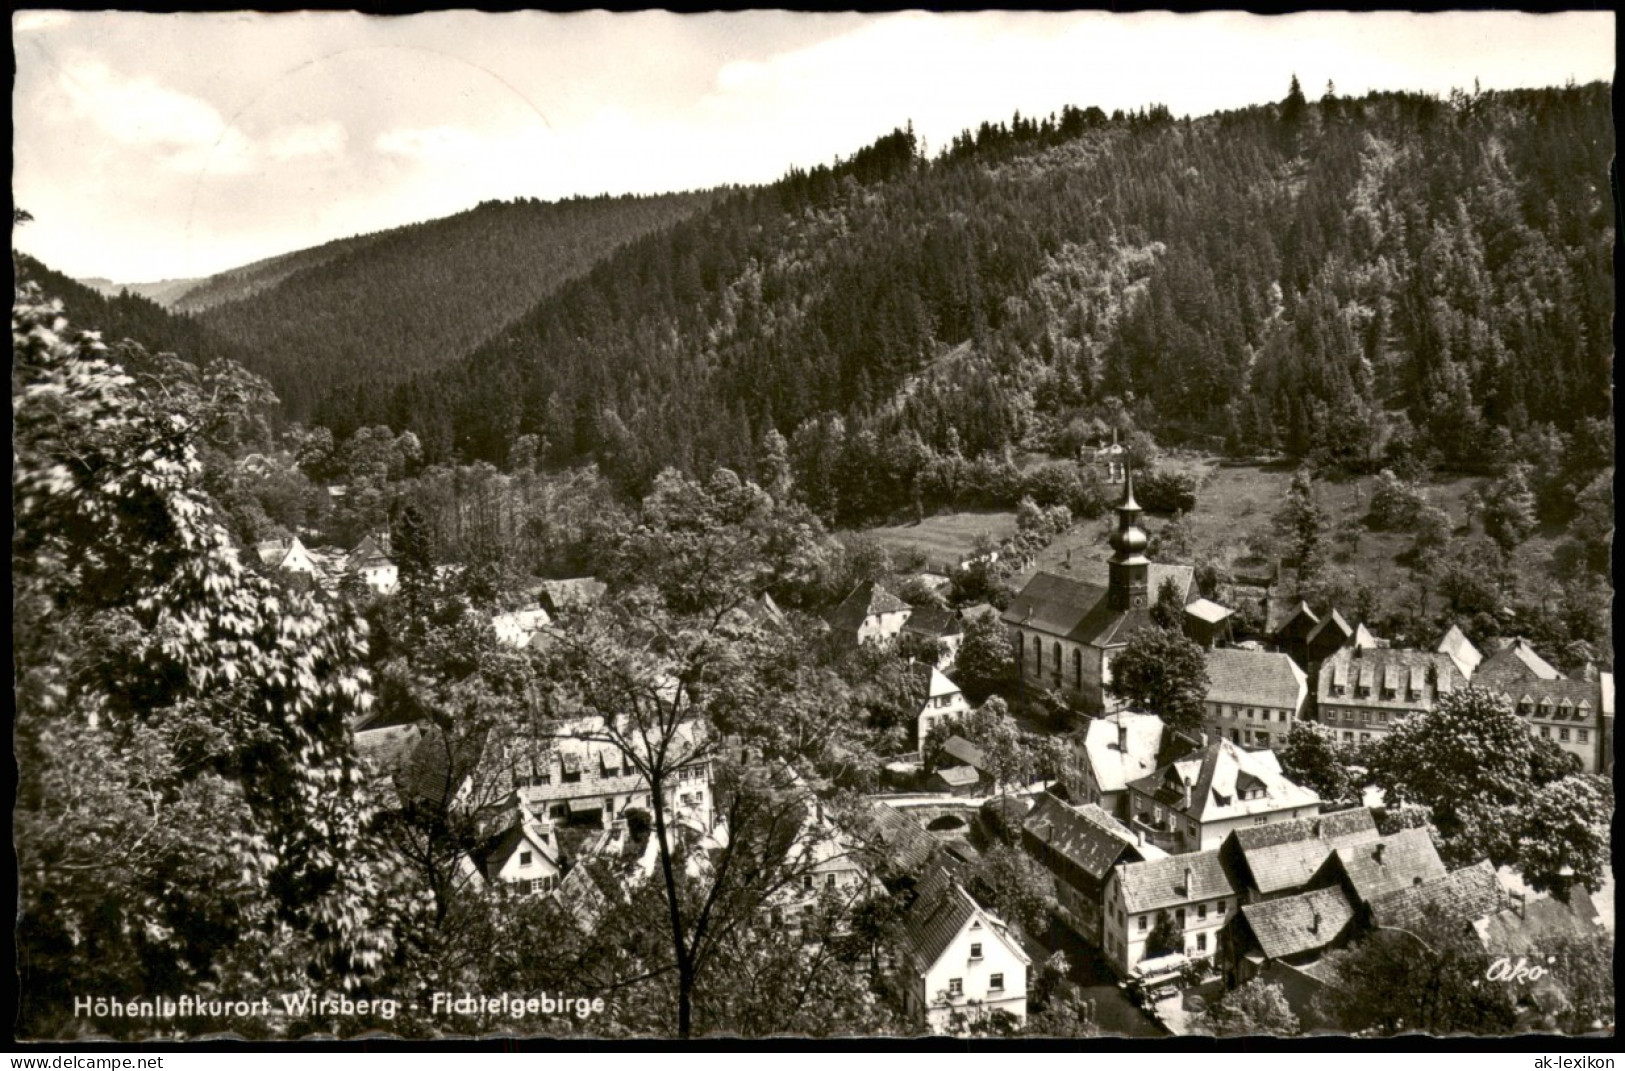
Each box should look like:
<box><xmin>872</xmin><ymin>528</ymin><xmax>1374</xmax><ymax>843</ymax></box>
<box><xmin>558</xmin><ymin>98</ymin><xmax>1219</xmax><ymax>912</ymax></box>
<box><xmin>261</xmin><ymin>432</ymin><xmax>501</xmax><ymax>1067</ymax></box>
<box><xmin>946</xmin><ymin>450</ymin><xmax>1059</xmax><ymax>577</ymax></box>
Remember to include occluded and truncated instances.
<box><xmin>11</xmin><ymin>288</ymin><xmax>388</xmax><ymax>1037</ymax></box>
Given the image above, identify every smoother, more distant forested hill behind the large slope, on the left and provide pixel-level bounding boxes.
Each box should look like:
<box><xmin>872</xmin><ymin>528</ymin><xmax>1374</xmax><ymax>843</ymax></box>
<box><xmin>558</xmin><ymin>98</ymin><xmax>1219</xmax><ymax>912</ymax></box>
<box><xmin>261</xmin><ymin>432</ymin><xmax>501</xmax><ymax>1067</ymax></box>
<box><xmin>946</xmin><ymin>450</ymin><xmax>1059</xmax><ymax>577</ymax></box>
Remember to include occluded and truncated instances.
<box><xmin>182</xmin><ymin>193</ymin><xmax>713</xmax><ymax>419</ymax></box>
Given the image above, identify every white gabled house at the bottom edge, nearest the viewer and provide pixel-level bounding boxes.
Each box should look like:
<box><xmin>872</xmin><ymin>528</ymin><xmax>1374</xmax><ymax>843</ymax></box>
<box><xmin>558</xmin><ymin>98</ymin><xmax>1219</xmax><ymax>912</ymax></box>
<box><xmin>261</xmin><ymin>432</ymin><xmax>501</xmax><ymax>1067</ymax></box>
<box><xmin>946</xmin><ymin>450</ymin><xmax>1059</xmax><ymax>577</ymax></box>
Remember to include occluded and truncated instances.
<box><xmin>902</xmin><ymin>866</ymin><xmax>1032</xmax><ymax>1034</ymax></box>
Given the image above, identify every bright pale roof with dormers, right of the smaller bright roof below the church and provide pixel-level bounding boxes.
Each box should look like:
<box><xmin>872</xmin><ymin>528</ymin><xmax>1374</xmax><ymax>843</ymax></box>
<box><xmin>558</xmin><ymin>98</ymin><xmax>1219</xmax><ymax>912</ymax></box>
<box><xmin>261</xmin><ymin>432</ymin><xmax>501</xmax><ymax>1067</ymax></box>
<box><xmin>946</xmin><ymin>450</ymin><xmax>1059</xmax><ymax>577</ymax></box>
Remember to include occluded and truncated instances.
<box><xmin>1129</xmin><ymin>738</ymin><xmax>1320</xmax><ymax>822</ymax></box>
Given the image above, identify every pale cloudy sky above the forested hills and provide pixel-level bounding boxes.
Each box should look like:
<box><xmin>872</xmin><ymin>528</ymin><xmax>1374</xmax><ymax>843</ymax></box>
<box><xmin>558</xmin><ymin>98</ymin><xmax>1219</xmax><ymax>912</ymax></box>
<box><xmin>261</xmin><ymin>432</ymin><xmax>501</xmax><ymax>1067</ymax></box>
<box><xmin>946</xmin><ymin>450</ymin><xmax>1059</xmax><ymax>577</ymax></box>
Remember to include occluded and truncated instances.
<box><xmin>11</xmin><ymin>10</ymin><xmax>1614</xmax><ymax>283</ymax></box>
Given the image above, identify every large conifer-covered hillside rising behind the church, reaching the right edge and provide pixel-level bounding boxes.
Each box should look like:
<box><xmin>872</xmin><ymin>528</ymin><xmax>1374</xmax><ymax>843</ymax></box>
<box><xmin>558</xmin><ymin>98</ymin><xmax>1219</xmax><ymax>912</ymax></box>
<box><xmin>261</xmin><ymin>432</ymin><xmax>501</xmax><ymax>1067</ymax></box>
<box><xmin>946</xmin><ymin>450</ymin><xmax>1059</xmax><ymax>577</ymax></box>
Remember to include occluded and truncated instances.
<box><xmin>368</xmin><ymin>85</ymin><xmax>1614</xmax><ymax>520</ymax></box>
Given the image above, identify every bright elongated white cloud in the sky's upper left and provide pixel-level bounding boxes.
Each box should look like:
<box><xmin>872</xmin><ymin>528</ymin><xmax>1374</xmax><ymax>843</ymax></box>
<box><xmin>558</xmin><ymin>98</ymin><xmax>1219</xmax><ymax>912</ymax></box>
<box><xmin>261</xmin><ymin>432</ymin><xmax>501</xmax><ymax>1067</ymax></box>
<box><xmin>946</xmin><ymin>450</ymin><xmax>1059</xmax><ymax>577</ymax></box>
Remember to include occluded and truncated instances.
<box><xmin>62</xmin><ymin>62</ymin><xmax>254</xmax><ymax>174</ymax></box>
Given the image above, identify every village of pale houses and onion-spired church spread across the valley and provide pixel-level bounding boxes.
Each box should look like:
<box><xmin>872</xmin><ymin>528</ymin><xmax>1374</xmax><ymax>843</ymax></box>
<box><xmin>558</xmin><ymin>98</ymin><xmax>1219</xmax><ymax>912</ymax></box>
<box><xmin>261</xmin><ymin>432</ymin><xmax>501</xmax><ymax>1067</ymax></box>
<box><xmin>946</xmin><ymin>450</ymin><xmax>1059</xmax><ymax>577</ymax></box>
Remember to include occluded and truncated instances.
<box><xmin>255</xmin><ymin>442</ymin><xmax>1614</xmax><ymax>1035</ymax></box>
